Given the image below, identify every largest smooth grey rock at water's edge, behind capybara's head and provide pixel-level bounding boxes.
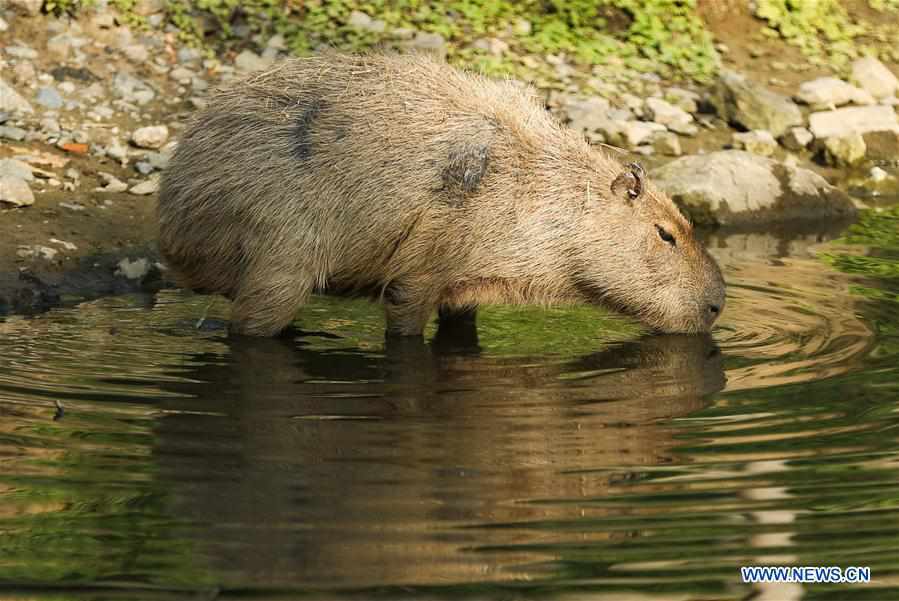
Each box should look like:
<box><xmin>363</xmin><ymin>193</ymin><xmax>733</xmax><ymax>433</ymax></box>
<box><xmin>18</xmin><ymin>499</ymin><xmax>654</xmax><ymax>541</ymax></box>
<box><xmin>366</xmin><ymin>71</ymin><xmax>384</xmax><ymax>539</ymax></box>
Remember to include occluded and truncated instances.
<box><xmin>651</xmin><ymin>150</ymin><xmax>855</xmax><ymax>225</ymax></box>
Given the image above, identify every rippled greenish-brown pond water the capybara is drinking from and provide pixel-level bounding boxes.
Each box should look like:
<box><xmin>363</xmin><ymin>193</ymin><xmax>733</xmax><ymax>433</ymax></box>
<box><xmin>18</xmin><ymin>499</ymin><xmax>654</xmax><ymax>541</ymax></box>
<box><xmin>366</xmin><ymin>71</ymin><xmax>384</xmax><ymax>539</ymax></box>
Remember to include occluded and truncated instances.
<box><xmin>0</xmin><ymin>210</ymin><xmax>899</xmax><ymax>600</ymax></box>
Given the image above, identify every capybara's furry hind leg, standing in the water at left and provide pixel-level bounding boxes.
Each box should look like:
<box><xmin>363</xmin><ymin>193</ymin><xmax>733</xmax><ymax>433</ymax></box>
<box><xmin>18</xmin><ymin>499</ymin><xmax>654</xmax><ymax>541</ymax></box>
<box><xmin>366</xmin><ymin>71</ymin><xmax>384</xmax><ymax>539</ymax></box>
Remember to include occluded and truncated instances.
<box><xmin>229</xmin><ymin>273</ymin><xmax>312</xmax><ymax>336</ymax></box>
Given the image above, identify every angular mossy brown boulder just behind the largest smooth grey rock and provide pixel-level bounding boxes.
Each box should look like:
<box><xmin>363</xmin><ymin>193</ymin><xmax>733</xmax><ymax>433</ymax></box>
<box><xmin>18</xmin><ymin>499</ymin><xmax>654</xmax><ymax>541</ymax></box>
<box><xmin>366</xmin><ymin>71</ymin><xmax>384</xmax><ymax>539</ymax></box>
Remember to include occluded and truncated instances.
<box><xmin>710</xmin><ymin>70</ymin><xmax>804</xmax><ymax>137</ymax></box>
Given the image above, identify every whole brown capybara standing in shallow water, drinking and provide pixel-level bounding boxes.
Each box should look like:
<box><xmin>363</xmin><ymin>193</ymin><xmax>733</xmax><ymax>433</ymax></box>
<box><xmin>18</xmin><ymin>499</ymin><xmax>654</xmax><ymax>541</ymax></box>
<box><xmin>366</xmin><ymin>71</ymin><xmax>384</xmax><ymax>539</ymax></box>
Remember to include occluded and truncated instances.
<box><xmin>159</xmin><ymin>54</ymin><xmax>724</xmax><ymax>335</ymax></box>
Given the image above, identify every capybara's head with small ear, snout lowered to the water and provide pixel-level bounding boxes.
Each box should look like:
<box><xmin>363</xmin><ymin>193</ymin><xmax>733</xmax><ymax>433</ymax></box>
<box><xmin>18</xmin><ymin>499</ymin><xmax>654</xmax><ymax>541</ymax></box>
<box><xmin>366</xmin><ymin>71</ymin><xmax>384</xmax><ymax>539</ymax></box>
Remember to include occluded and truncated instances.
<box><xmin>578</xmin><ymin>163</ymin><xmax>724</xmax><ymax>333</ymax></box>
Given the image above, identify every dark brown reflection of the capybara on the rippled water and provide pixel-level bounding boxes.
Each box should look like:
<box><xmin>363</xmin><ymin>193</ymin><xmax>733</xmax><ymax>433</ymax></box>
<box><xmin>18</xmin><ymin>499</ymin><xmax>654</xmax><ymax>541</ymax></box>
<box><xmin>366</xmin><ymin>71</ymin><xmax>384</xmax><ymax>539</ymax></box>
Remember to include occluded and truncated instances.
<box><xmin>153</xmin><ymin>332</ymin><xmax>724</xmax><ymax>587</ymax></box>
